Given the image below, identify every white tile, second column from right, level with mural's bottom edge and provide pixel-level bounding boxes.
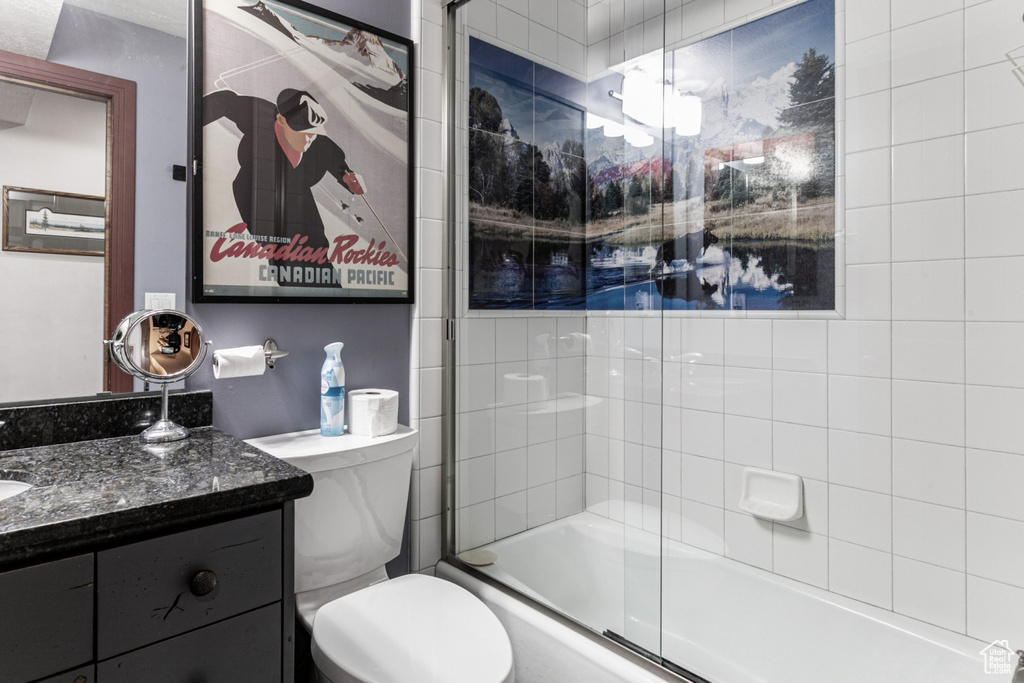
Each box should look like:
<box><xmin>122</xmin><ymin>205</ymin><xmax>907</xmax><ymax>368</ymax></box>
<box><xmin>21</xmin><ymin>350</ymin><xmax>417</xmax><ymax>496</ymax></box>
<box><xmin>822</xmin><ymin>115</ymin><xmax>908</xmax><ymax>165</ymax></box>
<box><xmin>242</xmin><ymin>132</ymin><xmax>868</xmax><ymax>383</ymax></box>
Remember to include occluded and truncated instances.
<box><xmin>892</xmin><ymin>260</ymin><xmax>965</xmax><ymax>321</ymax></box>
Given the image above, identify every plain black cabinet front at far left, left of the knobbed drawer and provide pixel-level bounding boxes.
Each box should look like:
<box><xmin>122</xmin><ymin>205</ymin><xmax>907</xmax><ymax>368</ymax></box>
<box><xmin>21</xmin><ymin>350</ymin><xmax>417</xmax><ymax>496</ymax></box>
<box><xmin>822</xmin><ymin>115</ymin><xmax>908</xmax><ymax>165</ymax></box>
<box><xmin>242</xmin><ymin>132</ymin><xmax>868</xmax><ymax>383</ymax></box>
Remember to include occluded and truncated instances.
<box><xmin>0</xmin><ymin>554</ymin><xmax>92</xmax><ymax>683</ymax></box>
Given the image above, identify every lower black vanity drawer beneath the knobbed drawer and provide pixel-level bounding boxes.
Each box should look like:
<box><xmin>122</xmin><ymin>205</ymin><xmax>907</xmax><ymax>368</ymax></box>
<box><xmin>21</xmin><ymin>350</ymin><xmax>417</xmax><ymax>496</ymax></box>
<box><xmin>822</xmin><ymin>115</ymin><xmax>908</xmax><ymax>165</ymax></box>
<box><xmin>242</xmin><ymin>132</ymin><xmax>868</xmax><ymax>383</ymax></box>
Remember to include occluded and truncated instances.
<box><xmin>96</xmin><ymin>602</ymin><xmax>282</xmax><ymax>683</ymax></box>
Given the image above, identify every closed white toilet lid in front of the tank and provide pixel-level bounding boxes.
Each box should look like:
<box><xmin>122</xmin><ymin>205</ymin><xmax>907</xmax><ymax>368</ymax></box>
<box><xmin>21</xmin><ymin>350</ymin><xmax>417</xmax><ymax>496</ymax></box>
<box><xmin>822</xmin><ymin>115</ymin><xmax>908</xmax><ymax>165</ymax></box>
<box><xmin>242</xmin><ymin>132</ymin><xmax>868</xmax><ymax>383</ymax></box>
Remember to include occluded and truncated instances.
<box><xmin>312</xmin><ymin>574</ymin><xmax>512</xmax><ymax>683</ymax></box>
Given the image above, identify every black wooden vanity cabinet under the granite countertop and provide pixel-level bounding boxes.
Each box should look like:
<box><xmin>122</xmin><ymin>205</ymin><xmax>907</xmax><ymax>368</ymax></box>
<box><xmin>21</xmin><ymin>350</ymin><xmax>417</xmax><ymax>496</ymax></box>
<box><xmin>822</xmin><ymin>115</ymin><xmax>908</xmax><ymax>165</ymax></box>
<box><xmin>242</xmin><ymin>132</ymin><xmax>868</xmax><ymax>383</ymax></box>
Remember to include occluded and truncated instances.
<box><xmin>0</xmin><ymin>509</ymin><xmax>294</xmax><ymax>683</ymax></box>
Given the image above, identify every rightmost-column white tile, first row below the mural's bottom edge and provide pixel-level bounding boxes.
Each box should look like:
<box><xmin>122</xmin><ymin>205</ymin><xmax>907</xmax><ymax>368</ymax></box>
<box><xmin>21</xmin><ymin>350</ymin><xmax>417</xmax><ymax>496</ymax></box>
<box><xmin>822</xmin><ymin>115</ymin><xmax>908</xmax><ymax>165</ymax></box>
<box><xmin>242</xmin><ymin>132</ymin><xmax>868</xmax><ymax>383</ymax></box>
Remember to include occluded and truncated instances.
<box><xmin>966</xmin><ymin>323</ymin><xmax>1024</xmax><ymax>389</ymax></box>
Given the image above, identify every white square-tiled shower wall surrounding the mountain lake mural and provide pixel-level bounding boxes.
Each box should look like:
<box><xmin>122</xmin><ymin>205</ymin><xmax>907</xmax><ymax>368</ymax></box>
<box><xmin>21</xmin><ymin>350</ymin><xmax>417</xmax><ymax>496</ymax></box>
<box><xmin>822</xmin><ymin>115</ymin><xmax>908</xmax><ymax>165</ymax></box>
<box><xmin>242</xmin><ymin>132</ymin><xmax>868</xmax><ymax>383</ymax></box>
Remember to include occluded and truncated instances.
<box><xmin>425</xmin><ymin>0</ymin><xmax>1024</xmax><ymax>642</ymax></box>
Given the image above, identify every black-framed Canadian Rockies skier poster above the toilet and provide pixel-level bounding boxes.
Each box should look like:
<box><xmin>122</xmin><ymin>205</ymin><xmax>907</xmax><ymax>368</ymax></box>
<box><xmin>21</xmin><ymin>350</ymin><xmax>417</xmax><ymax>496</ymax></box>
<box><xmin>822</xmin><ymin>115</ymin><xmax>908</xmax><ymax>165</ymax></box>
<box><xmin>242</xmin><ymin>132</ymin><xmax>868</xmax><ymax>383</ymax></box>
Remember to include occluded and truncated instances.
<box><xmin>190</xmin><ymin>0</ymin><xmax>414</xmax><ymax>303</ymax></box>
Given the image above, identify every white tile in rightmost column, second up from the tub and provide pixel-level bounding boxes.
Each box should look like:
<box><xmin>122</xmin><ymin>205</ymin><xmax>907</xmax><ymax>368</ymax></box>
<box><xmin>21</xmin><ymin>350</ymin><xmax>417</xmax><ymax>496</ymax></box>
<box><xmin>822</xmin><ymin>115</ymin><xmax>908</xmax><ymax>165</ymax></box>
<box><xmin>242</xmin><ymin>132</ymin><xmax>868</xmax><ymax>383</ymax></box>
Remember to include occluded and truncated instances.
<box><xmin>967</xmin><ymin>512</ymin><xmax>1024</xmax><ymax>588</ymax></box>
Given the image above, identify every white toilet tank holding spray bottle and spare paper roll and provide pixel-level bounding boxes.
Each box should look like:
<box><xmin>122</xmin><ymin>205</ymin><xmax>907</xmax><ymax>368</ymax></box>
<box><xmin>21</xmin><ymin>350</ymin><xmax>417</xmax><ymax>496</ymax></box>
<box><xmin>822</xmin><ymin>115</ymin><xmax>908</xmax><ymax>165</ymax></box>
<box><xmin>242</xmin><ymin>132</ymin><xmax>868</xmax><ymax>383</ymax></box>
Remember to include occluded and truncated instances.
<box><xmin>246</xmin><ymin>426</ymin><xmax>419</xmax><ymax>593</ymax></box>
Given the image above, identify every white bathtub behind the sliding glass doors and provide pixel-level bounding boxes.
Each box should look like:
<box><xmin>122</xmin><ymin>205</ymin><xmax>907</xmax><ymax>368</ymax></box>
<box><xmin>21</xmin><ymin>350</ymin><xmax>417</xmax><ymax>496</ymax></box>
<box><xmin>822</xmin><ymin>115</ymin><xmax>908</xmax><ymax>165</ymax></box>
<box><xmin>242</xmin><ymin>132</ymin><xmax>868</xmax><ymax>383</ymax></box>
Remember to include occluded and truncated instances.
<box><xmin>437</xmin><ymin>512</ymin><xmax>991</xmax><ymax>683</ymax></box>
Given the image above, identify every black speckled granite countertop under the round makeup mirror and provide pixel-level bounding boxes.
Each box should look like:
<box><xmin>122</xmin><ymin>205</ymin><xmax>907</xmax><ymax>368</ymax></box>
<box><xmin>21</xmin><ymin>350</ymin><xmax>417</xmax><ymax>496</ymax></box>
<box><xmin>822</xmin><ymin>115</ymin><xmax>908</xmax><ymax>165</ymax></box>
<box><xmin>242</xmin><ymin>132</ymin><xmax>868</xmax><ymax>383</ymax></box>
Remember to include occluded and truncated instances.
<box><xmin>0</xmin><ymin>427</ymin><xmax>313</xmax><ymax>568</ymax></box>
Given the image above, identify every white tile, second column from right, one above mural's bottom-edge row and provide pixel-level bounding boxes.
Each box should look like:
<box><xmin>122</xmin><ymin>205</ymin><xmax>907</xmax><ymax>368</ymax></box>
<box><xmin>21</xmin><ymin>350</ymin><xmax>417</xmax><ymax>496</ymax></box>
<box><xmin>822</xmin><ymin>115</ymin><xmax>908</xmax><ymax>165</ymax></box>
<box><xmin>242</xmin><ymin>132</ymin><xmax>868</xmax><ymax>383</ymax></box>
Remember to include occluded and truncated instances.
<box><xmin>892</xmin><ymin>198</ymin><xmax>965</xmax><ymax>261</ymax></box>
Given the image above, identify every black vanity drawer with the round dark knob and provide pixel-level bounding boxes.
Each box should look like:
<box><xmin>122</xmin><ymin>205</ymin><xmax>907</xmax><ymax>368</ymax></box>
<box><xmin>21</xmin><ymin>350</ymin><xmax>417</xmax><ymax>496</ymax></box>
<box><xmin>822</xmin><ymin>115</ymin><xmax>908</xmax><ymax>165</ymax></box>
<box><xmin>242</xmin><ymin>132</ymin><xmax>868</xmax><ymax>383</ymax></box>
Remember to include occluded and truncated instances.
<box><xmin>96</xmin><ymin>510</ymin><xmax>282</xmax><ymax>659</ymax></box>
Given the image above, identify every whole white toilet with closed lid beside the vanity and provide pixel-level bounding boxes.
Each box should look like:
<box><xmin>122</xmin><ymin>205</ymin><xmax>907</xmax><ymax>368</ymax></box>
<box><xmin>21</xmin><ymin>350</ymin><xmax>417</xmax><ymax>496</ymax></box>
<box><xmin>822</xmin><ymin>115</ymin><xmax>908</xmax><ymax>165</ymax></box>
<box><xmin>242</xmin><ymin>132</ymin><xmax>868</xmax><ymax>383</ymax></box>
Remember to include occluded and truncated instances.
<box><xmin>247</xmin><ymin>427</ymin><xmax>514</xmax><ymax>683</ymax></box>
